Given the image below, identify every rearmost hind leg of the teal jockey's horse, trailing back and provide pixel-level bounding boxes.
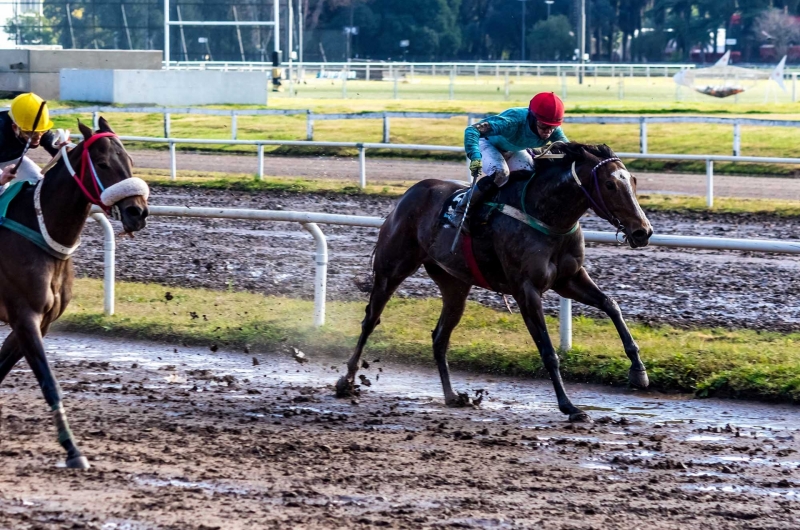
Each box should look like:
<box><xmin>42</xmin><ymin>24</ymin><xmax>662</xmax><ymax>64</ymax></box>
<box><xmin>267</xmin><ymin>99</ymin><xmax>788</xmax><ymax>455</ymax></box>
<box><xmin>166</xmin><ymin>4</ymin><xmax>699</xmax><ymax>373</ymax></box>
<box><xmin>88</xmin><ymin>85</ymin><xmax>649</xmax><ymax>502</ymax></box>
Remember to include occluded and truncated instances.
<box><xmin>336</xmin><ymin>252</ymin><xmax>420</xmax><ymax>398</ymax></box>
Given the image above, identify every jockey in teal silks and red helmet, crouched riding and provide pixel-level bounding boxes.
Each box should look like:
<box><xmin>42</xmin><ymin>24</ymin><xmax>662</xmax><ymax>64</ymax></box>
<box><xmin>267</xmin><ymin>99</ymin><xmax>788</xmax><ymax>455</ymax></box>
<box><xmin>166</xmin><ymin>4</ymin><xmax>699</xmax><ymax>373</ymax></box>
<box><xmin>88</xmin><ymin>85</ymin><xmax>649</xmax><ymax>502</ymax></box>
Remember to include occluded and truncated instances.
<box><xmin>456</xmin><ymin>92</ymin><xmax>569</xmax><ymax>215</ymax></box>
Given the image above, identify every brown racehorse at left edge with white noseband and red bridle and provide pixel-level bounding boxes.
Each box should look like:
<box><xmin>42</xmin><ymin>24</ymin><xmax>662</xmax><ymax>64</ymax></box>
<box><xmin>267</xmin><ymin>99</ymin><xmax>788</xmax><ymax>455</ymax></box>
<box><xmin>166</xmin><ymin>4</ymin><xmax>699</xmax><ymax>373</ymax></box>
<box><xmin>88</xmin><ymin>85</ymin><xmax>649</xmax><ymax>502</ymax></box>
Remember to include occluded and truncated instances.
<box><xmin>0</xmin><ymin>118</ymin><xmax>149</xmax><ymax>468</ymax></box>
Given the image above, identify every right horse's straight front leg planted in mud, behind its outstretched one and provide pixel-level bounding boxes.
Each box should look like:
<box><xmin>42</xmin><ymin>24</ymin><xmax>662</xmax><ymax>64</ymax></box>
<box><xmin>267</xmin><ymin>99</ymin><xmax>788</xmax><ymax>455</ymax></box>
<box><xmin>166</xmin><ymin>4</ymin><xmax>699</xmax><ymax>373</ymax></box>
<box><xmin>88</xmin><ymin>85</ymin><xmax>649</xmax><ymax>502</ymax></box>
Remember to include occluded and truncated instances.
<box><xmin>514</xmin><ymin>282</ymin><xmax>591</xmax><ymax>422</ymax></box>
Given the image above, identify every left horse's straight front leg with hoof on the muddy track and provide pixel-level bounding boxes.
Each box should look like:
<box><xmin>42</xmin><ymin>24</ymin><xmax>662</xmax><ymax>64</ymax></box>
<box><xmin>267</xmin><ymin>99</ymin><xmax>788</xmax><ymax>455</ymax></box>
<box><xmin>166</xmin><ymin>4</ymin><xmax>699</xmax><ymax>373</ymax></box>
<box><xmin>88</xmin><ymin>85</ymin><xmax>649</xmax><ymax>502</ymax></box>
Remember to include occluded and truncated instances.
<box><xmin>14</xmin><ymin>316</ymin><xmax>89</xmax><ymax>469</ymax></box>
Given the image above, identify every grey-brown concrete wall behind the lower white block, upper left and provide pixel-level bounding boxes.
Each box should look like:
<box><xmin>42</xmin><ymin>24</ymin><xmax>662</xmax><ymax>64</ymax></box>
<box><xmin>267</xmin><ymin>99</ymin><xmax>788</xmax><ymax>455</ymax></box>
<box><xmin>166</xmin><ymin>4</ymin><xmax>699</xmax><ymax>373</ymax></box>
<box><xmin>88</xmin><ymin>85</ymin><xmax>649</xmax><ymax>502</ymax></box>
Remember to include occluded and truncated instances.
<box><xmin>0</xmin><ymin>49</ymin><xmax>162</xmax><ymax>99</ymax></box>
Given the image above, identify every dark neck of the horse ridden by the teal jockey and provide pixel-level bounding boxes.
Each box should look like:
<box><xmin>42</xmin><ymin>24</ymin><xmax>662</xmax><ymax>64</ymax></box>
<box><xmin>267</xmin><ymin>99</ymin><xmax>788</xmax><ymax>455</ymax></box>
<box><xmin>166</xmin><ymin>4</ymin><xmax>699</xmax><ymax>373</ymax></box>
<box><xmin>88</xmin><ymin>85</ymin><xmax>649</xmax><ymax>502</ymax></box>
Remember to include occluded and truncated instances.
<box><xmin>502</xmin><ymin>166</ymin><xmax>589</xmax><ymax>230</ymax></box>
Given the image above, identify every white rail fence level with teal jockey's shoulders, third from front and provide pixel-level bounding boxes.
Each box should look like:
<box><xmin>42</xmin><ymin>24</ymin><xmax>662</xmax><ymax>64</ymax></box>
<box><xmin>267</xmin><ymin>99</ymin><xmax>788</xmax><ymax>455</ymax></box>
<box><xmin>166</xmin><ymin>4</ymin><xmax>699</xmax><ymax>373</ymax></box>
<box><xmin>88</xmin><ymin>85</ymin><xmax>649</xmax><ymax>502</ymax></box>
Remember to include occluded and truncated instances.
<box><xmin>50</xmin><ymin>106</ymin><xmax>800</xmax><ymax>156</ymax></box>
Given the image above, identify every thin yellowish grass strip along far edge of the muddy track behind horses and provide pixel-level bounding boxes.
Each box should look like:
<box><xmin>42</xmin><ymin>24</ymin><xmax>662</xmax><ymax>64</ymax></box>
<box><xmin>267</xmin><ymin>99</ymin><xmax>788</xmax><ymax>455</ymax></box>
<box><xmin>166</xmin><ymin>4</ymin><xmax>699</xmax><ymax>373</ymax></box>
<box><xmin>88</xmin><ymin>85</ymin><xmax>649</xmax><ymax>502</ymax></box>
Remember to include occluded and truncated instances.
<box><xmin>135</xmin><ymin>169</ymin><xmax>800</xmax><ymax>217</ymax></box>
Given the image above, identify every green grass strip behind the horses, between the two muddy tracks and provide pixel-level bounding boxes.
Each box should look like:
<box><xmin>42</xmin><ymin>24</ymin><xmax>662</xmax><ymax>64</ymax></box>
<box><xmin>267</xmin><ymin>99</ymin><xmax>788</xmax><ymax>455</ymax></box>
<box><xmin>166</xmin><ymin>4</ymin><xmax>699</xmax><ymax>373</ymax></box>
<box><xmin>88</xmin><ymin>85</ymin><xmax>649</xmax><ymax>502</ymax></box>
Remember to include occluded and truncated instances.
<box><xmin>58</xmin><ymin>279</ymin><xmax>800</xmax><ymax>402</ymax></box>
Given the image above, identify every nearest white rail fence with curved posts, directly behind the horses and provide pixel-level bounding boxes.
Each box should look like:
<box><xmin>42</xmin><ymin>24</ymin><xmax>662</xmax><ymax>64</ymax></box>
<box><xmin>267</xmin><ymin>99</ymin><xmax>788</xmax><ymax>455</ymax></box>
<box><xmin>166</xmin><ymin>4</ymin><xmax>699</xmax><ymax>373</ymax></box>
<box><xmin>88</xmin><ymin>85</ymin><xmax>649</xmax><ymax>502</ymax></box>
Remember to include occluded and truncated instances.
<box><xmin>84</xmin><ymin>206</ymin><xmax>800</xmax><ymax>350</ymax></box>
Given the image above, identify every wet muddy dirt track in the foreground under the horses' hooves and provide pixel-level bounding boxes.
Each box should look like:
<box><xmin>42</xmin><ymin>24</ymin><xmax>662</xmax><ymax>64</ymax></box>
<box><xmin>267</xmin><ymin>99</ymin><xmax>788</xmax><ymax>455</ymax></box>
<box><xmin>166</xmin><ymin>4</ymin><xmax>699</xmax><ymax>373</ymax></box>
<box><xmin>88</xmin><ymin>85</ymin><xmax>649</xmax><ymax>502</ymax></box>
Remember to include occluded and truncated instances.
<box><xmin>0</xmin><ymin>334</ymin><xmax>800</xmax><ymax>530</ymax></box>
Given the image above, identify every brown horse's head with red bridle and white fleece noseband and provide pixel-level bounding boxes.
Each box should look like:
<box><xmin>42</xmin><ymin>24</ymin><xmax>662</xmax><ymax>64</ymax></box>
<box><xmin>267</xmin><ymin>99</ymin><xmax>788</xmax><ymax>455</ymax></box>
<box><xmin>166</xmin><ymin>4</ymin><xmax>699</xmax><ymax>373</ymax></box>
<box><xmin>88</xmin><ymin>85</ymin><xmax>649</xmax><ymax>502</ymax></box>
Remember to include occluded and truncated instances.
<box><xmin>76</xmin><ymin>118</ymin><xmax>150</xmax><ymax>233</ymax></box>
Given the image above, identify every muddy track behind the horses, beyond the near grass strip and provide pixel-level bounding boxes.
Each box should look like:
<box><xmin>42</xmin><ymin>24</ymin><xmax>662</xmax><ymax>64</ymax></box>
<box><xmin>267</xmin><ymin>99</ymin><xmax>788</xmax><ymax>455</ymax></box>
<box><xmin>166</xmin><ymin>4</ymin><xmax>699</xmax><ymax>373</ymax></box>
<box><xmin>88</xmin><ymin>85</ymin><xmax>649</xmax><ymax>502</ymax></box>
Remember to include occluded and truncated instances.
<box><xmin>75</xmin><ymin>184</ymin><xmax>800</xmax><ymax>331</ymax></box>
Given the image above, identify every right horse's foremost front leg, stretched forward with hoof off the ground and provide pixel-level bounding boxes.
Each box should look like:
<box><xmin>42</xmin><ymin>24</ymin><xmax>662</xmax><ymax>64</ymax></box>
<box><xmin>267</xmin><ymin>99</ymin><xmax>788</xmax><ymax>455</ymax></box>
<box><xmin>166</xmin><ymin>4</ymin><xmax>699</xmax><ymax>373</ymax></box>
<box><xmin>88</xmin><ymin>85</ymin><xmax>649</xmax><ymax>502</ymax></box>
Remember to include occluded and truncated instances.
<box><xmin>553</xmin><ymin>268</ymin><xmax>650</xmax><ymax>388</ymax></box>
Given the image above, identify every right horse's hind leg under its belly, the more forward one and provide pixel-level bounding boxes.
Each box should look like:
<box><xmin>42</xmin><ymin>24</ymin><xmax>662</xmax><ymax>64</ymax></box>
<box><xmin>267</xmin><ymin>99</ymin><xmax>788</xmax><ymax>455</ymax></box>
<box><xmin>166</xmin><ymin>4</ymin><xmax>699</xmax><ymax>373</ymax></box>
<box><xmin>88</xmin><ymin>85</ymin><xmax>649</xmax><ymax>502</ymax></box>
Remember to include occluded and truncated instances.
<box><xmin>425</xmin><ymin>264</ymin><xmax>472</xmax><ymax>407</ymax></box>
